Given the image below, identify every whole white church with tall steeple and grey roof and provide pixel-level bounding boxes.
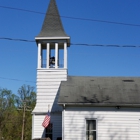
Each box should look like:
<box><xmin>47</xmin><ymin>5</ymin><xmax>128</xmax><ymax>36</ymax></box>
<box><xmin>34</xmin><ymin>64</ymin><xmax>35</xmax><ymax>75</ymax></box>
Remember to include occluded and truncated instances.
<box><xmin>32</xmin><ymin>0</ymin><xmax>140</xmax><ymax>140</ymax></box>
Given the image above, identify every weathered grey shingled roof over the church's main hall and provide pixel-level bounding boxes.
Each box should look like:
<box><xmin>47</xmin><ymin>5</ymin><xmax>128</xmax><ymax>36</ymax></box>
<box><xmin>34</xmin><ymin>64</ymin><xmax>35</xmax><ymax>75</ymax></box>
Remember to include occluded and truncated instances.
<box><xmin>58</xmin><ymin>77</ymin><xmax>140</xmax><ymax>106</ymax></box>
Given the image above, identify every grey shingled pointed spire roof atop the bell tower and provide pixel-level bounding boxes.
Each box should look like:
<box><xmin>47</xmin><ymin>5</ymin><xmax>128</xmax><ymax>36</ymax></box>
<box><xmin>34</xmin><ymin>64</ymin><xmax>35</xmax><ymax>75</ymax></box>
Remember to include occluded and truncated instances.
<box><xmin>36</xmin><ymin>0</ymin><xmax>70</xmax><ymax>39</ymax></box>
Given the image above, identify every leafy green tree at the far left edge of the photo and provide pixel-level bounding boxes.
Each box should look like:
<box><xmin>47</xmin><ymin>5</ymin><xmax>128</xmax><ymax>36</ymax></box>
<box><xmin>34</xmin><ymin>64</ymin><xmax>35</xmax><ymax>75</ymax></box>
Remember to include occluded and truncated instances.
<box><xmin>0</xmin><ymin>89</ymin><xmax>16</xmax><ymax>138</ymax></box>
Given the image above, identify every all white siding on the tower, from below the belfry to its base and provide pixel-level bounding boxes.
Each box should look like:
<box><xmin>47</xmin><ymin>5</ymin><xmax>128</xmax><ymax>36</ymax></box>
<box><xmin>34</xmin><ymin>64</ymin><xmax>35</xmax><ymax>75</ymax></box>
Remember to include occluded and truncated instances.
<box><xmin>32</xmin><ymin>69</ymin><xmax>67</xmax><ymax>140</ymax></box>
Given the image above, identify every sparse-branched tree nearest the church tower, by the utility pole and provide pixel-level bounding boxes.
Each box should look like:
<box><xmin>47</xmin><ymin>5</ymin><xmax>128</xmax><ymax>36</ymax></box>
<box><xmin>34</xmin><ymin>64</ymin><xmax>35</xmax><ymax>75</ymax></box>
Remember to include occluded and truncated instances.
<box><xmin>18</xmin><ymin>85</ymin><xmax>36</xmax><ymax>140</ymax></box>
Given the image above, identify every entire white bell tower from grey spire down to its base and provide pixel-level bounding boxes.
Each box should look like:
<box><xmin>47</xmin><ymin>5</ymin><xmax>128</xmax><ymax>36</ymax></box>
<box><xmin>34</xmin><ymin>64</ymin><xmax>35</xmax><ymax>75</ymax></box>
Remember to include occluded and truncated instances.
<box><xmin>32</xmin><ymin>0</ymin><xmax>70</xmax><ymax>139</ymax></box>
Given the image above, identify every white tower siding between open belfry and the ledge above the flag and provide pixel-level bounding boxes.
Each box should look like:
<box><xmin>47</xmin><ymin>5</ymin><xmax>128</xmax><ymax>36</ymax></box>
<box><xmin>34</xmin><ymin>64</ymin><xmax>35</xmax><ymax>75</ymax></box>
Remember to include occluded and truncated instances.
<box><xmin>33</xmin><ymin>68</ymin><xmax>67</xmax><ymax>113</ymax></box>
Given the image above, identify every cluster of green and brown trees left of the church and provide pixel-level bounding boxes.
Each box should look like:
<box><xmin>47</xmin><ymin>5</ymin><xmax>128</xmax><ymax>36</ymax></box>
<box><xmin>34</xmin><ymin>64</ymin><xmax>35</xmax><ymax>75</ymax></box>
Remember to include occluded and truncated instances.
<box><xmin>0</xmin><ymin>85</ymin><xmax>36</xmax><ymax>140</ymax></box>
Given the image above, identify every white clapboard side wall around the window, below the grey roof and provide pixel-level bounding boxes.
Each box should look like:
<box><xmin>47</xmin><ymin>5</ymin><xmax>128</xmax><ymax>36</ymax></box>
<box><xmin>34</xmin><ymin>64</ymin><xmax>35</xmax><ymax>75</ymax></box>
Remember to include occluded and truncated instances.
<box><xmin>64</xmin><ymin>107</ymin><xmax>140</xmax><ymax>140</ymax></box>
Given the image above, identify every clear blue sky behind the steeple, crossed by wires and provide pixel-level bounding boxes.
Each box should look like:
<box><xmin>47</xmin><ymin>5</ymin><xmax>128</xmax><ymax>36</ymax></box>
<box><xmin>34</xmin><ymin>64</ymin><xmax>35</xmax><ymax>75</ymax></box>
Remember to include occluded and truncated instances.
<box><xmin>0</xmin><ymin>0</ymin><xmax>140</xmax><ymax>93</ymax></box>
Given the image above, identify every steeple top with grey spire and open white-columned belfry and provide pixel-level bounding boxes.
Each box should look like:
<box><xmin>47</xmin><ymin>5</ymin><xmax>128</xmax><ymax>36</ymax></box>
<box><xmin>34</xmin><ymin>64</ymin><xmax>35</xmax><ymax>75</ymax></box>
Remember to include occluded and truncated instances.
<box><xmin>35</xmin><ymin>0</ymin><xmax>70</xmax><ymax>69</ymax></box>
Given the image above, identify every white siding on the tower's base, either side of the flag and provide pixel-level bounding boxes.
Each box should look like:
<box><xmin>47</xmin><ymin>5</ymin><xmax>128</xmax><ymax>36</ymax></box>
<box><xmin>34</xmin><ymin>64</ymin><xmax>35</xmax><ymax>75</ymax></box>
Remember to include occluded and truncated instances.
<box><xmin>32</xmin><ymin>113</ymin><xmax>62</xmax><ymax>140</ymax></box>
